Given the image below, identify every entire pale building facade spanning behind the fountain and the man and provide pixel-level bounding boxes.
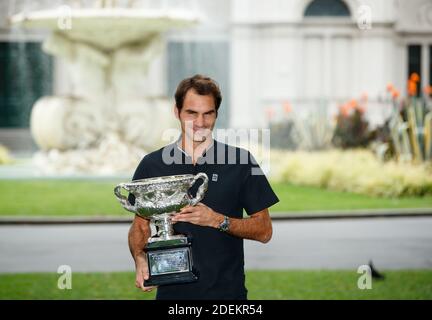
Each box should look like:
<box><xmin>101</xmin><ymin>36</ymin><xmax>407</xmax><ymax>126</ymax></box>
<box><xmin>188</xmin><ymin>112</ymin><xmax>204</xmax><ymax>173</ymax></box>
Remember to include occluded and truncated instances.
<box><xmin>0</xmin><ymin>0</ymin><xmax>432</xmax><ymax>149</ymax></box>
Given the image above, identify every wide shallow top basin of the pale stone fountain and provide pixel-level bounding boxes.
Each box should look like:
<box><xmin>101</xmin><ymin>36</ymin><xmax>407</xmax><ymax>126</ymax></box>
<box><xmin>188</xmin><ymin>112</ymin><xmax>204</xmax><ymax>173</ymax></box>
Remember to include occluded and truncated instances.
<box><xmin>10</xmin><ymin>7</ymin><xmax>198</xmax><ymax>50</ymax></box>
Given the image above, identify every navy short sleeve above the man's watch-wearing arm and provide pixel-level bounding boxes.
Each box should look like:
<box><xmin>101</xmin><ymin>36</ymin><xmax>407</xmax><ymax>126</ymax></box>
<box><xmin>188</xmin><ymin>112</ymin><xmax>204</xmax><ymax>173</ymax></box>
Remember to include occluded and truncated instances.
<box><xmin>240</xmin><ymin>153</ymin><xmax>279</xmax><ymax>215</ymax></box>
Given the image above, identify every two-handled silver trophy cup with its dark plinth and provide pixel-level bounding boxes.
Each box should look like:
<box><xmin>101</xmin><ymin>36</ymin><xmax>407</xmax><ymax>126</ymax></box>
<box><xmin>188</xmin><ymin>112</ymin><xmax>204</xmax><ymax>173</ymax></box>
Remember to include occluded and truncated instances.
<box><xmin>114</xmin><ymin>173</ymin><xmax>208</xmax><ymax>286</ymax></box>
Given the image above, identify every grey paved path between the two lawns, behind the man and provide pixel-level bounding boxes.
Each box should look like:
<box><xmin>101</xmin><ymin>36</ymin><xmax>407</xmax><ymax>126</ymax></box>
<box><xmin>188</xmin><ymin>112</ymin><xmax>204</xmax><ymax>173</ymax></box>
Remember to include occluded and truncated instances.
<box><xmin>0</xmin><ymin>217</ymin><xmax>432</xmax><ymax>272</ymax></box>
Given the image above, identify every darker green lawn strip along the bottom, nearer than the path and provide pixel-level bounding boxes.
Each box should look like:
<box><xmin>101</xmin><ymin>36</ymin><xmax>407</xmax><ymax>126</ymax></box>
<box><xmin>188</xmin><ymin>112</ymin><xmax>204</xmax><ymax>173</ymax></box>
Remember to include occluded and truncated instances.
<box><xmin>0</xmin><ymin>270</ymin><xmax>432</xmax><ymax>300</ymax></box>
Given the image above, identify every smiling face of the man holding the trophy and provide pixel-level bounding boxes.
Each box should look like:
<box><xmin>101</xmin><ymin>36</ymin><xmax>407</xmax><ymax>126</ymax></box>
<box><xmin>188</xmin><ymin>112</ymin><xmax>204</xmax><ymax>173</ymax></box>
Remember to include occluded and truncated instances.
<box><xmin>174</xmin><ymin>89</ymin><xmax>217</xmax><ymax>142</ymax></box>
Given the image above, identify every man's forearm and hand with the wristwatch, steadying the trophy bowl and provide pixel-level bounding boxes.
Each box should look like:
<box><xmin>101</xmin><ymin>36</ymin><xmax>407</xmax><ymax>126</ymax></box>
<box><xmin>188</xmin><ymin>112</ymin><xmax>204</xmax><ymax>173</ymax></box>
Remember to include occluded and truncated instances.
<box><xmin>173</xmin><ymin>203</ymin><xmax>273</xmax><ymax>243</ymax></box>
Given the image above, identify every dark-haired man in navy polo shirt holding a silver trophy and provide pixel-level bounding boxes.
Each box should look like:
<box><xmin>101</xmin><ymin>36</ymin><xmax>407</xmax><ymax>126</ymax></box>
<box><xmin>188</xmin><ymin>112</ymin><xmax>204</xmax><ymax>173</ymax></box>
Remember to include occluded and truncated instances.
<box><xmin>129</xmin><ymin>75</ymin><xmax>279</xmax><ymax>300</ymax></box>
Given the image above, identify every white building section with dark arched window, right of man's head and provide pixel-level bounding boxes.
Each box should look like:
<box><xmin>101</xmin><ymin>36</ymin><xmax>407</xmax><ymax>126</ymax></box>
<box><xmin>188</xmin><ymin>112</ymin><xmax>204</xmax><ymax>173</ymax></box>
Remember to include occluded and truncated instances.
<box><xmin>230</xmin><ymin>0</ymin><xmax>432</xmax><ymax>127</ymax></box>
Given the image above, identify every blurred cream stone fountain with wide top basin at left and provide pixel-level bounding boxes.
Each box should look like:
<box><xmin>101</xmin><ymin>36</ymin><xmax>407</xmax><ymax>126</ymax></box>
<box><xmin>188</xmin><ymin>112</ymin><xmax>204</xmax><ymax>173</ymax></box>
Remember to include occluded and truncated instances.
<box><xmin>10</xmin><ymin>1</ymin><xmax>198</xmax><ymax>174</ymax></box>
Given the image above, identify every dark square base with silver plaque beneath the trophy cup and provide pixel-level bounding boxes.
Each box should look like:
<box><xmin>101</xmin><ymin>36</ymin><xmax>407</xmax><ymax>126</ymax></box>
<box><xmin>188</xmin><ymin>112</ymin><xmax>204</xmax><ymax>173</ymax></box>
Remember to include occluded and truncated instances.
<box><xmin>144</xmin><ymin>235</ymin><xmax>198</xmax><ymax>287</ymax></box>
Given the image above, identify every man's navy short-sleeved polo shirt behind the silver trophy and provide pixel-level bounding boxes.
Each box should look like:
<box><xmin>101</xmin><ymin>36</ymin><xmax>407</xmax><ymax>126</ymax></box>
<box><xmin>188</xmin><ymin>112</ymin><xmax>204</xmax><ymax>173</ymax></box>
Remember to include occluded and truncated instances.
<box><xmin>130</xmin><ymin>140</ymin><xmax>279</xmax><ymax>300</ymax></box>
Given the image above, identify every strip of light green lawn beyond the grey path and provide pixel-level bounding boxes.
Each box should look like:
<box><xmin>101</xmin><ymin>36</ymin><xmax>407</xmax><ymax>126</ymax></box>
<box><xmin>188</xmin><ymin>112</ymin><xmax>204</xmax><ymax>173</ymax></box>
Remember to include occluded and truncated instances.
<box><xmin>0</xmin><ymin>180</ymin><xmax>432</xmax><ymax>216</ymax></box>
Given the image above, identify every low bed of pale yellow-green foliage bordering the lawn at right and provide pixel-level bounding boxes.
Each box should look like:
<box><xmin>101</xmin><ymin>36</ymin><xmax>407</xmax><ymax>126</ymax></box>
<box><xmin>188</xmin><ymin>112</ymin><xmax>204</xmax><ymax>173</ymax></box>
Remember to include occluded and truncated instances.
<box><xmin>272</xmin><ymin>149</ymin><xmax>432</xmax><ymax>197</ymax></box>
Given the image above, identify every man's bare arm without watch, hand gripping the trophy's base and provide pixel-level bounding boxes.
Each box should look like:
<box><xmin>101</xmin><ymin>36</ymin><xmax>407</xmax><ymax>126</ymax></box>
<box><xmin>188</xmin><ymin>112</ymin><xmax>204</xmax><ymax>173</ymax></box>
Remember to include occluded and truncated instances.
<box><xmin>128</xmin><ymin>215</ymin><xmax>153</xmax><ymax>291</ymax></box>
